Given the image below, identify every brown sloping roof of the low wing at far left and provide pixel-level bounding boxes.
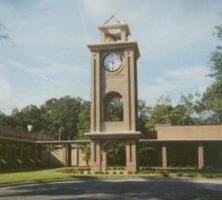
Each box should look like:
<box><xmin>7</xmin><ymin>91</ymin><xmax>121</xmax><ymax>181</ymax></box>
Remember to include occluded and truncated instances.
<box><xmin>0</xmin><ymin>127</ymin><xmax>55</xmax><ymax>141</ymax></box>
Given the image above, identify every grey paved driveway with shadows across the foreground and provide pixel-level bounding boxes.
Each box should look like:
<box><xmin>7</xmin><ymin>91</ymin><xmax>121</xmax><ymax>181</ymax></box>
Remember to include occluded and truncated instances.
<box><xmin>0</xmin><ymin>178</ymin><xmax>222</xmax><ymax>200</ymax></box>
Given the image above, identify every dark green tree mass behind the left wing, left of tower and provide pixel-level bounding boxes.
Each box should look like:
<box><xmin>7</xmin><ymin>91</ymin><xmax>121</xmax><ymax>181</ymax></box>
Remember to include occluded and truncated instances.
<box><xmin>0</xmin><ymin>96</ymin><xmax>90</xmax><ymax>139</ymax></box>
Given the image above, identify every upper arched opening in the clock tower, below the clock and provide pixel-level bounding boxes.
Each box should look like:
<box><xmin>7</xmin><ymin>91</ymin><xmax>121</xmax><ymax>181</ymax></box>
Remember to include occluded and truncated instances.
<box><xmin>104</xmin><ymin>92</ymin><xmax>123</xmax><ymax>122</ymax></box>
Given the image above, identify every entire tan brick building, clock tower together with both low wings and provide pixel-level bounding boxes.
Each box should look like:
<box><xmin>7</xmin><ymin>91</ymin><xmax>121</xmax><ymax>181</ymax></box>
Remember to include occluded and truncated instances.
<box><xmin>0</xmin><ymin>16</ymin><xmax>222</xmax><ymax>172</ymax></box>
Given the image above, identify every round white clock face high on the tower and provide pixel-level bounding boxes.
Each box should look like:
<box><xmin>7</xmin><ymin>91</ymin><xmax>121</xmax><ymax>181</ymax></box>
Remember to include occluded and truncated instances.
<box><xmin>103</xmin><ymin>53</ymin><xmax>122</xmax><ymax>72</ymax></box>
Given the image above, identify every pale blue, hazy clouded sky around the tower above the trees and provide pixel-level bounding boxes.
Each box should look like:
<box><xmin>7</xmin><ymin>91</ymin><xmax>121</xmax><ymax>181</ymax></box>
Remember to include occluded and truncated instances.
<box><xmin>0</xmin><ymin>0</ymin><xmax>222</xmax><ymax>114</ymax></box>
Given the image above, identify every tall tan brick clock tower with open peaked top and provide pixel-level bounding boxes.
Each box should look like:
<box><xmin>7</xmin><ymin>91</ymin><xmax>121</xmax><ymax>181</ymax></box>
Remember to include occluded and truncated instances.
<box><xmin>86</xmin><ymin>16</ymin><xmax>140</xmax><ymax>172</ymax></box>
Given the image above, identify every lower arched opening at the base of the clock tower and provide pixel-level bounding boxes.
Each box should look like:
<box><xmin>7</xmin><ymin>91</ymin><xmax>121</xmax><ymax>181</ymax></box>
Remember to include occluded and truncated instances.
<box><xmin>106</xmin><ymin>143</ymin><xmax>126</xmax><ymax>167</ymax></box>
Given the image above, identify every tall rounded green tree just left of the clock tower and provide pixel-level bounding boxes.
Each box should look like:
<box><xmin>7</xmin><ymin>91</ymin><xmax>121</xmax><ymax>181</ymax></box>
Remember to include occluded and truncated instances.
<box><xmin>41</xmin><ymin>96</ymin><xmax>86</xmax><ymax>139</ymax></box>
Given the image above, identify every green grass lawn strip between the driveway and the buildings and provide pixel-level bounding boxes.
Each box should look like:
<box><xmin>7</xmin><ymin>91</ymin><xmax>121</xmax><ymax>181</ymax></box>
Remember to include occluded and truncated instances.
<box><xmin>0</xmin><ymin>167</ymin><xmax>222</xmax><ymax>185</ymax></box>
